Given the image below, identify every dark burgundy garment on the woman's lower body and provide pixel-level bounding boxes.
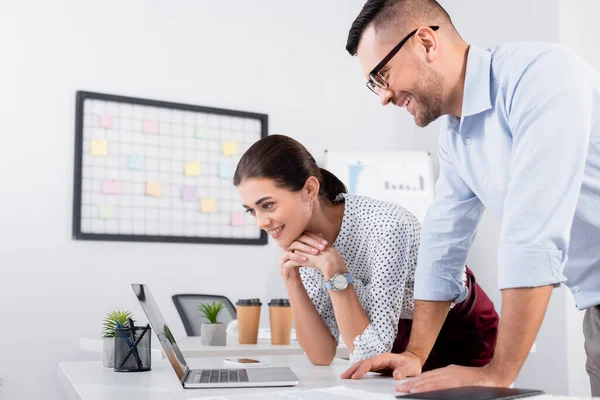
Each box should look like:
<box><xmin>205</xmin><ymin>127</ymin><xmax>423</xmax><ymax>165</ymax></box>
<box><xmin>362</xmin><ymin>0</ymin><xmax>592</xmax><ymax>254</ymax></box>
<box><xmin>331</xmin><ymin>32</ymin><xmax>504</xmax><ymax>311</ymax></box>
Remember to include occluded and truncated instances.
<box><xmin>392</xmin><ymin>268</ymin><xmax>499</xmax><ymax>372</ymax></box>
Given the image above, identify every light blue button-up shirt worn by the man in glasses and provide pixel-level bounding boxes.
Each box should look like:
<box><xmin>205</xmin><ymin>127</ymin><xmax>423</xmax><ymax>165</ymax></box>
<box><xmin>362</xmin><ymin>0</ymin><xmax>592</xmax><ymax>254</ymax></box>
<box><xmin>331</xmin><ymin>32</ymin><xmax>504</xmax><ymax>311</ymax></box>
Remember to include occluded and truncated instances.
<box><xmin>415</xmin><ymin>43</ymin><xmax>600</xmax><ymax>309</ymax></box>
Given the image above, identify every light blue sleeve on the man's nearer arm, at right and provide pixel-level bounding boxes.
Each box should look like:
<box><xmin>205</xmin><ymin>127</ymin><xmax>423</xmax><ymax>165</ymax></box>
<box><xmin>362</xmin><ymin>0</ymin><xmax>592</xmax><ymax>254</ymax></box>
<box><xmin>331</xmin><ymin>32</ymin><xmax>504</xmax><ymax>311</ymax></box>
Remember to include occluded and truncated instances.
<box><xmin>498</xmin><ymin>51</ymin><xmax>598</xmax><ymax>289</ymax></box>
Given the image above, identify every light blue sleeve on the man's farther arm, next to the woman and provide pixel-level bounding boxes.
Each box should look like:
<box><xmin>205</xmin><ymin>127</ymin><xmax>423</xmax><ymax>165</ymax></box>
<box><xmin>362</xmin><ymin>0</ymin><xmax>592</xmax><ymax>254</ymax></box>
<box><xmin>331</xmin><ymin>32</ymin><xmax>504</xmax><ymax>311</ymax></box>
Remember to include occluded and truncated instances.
<box><xmin>415</xmin><ymin>136</ymin><xmax>485</xmax><ymax>303</ymax></box>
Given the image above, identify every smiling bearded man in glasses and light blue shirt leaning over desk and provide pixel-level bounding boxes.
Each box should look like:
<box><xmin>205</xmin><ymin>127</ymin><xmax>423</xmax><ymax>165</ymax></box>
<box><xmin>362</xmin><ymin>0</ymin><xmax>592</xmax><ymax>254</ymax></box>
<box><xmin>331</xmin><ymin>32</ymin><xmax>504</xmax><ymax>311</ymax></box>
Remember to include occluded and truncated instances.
<box><xmin>342</xmin><ymin>0</ymin><xmax>600</xmax><ymax>396</ymax></box>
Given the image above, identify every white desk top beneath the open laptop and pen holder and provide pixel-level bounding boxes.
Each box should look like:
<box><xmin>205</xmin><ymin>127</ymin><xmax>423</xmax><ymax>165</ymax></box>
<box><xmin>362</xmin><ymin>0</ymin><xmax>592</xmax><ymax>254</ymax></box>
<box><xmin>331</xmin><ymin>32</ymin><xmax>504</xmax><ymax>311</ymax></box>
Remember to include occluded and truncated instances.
<box><xmin>58</xmin><ymin>355</ymin><xmax>397</xmax><ymax>400</ymax></box>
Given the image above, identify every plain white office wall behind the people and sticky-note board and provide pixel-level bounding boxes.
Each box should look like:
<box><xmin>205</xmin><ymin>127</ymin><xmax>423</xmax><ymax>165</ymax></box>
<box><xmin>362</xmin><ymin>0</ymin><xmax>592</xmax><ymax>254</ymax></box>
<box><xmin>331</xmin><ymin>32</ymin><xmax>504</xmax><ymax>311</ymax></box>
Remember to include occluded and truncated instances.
<box><xmin>0</xmin><ymin>0</ymin><xmax>591</xmax><ymax>399</ymax></box>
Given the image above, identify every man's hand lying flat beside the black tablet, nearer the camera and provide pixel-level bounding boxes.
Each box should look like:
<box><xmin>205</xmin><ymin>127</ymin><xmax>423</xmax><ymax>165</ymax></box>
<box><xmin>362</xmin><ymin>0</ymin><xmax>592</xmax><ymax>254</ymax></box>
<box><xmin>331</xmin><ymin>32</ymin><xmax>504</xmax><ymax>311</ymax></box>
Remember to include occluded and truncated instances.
<box><xmin>396</xmin><ymin>365</ymin><xmax>508</xmax><ymax>393</ymax></box>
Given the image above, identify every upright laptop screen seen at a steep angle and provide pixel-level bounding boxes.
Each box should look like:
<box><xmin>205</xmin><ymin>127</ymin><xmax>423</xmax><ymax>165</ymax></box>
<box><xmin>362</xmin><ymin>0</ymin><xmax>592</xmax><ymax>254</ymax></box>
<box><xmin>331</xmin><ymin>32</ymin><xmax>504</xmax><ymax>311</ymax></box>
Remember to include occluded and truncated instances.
<box><xmin>131</xmin><ymin>283</ymin><xmax>189</xmax><ymax>382</ymax></box>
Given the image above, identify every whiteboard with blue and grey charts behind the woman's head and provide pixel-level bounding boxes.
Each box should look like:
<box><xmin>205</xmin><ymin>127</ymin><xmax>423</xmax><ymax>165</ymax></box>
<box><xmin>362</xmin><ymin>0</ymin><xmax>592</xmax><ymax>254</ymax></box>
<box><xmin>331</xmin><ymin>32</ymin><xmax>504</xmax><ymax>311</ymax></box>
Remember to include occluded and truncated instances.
<box><xmin>325</xmin><ymin>151</ymin><xmax>435</xmax><ymax>223</ymax></box>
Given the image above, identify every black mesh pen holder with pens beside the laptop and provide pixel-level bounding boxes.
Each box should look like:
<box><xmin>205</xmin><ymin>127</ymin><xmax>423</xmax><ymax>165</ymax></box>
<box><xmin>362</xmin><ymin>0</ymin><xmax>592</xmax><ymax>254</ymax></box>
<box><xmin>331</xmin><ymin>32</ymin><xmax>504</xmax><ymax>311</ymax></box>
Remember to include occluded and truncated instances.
<box><xmin>114</xmin><ymin>326</ymin><xmax>152</xmax><ymax>372</ymax></box>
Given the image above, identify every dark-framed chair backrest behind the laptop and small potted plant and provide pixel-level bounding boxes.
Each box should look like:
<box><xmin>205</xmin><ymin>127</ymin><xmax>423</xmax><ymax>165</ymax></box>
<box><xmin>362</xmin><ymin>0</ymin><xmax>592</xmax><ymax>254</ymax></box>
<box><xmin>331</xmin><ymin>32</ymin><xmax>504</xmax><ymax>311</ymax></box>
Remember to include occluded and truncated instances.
<box><xmin>172</xmin><ymin>294</ymin><xmax>237</xmax><ymax>336</ymax></box>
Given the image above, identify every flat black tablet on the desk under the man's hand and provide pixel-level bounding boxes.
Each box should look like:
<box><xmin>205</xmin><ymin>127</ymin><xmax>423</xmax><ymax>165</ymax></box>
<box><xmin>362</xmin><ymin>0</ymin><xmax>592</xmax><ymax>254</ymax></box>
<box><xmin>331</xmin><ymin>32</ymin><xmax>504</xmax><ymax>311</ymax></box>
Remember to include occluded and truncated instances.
<box><xmin>396</xmin><ymin>386</ymin><xmax>544</xmax><ymax>400</ymax></box>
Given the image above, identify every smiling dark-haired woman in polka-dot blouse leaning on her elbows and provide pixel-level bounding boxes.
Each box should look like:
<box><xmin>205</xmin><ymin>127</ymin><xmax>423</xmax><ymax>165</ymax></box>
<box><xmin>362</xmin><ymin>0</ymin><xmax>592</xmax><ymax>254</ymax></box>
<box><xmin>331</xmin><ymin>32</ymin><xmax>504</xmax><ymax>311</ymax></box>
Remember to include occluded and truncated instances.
<box><xmin>234</xmin><ymin>135</ymin><xmax>498</xmax><ymax>370</ymax></box>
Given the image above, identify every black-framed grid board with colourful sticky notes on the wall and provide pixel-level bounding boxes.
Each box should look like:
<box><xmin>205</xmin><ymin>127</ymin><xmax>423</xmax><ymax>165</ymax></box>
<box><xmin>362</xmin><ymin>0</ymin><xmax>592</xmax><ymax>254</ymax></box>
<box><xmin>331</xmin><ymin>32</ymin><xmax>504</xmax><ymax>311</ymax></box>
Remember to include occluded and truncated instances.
<box><xmin>73</xmin><ymin>91</ymin><xmax>268</xmax><ymax>245</ymax></box>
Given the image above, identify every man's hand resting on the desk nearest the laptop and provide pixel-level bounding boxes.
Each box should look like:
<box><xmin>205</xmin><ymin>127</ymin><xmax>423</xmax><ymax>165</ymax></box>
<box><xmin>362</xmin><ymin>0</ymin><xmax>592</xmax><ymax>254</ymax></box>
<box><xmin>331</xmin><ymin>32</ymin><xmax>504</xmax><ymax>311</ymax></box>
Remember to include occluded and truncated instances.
<box><xmin>341</xmin><ymin>352</ymin><xmax>421</xmax><ymax>379</ymax></box>
